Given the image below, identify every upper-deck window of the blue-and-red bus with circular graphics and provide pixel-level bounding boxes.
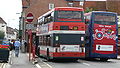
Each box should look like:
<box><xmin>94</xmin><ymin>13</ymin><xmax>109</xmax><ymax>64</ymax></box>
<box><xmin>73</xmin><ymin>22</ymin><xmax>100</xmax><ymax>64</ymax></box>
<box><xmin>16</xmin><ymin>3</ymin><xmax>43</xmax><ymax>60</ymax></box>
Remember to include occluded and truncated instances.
<box><xmin>94</xmin><ymin>13</ymin><xmax>116</xmax><ymax>25</ymax></box>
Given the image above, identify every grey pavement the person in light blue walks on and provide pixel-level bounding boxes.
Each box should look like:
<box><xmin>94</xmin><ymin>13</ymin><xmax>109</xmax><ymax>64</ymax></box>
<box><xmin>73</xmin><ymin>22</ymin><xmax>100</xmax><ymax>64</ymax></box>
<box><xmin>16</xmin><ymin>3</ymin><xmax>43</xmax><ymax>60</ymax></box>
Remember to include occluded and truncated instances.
<box><xmin>7</xmin><ymin>52</ymin><xmax>37</xmax><ymax>68</ymax></box>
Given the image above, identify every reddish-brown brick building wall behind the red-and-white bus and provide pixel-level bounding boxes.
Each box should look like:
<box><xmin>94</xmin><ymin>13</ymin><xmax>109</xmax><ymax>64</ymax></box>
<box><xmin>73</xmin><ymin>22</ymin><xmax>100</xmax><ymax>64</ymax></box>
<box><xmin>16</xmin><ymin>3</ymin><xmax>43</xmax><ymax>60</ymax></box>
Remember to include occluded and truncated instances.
<box><xmin>22</xmin><ymin>0</ymin><xmax>80</xmax><ymax>22</ymax></box>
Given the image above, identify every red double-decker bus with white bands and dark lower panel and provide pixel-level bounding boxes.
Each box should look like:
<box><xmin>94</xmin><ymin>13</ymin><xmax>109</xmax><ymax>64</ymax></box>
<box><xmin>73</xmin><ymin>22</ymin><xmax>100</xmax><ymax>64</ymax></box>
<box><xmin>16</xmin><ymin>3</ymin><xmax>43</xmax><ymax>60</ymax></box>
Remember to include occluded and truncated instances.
<box><xmin>36</xmin><ymin>7</ymin><xmax>85</xmax><ymax>59</ymax></box>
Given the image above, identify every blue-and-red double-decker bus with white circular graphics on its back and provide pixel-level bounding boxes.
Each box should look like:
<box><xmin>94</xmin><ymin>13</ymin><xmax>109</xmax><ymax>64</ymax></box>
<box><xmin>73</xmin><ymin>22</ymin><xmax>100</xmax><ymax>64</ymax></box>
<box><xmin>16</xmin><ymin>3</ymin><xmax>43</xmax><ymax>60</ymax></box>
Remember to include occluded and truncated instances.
<box><xmin>85</xmin><ymin>11</ymin><xmax>118</xmax><ymax>61</ymax></box>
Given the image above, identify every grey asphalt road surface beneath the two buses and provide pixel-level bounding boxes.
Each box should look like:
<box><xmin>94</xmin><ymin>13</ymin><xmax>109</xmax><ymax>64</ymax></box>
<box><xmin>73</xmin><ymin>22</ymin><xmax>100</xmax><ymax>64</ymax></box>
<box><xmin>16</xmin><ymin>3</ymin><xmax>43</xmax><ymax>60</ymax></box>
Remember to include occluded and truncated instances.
<box><xmin>46</xmin><ymin>59</ymin><xmax>120</xmax><ymax>68</ymax></box>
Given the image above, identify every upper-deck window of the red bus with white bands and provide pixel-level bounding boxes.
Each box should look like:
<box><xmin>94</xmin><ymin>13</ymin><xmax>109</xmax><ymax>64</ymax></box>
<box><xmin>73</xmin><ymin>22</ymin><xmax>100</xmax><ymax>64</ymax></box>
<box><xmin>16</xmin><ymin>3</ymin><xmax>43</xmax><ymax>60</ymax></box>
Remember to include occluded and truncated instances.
<box><xmin>58</xmin><ymin>11</ymin><xmax>82</xmax><ymax>19</ymax></box>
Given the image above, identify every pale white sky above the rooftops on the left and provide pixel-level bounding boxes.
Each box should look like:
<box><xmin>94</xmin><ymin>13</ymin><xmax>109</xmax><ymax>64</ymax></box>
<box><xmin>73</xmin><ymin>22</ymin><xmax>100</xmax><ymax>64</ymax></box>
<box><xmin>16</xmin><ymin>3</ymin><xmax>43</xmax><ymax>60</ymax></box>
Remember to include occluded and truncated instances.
<box><xmin>0</xmin><ymin>0</ymin><xmax>22</xmax><ymax>29</ymax></box>
